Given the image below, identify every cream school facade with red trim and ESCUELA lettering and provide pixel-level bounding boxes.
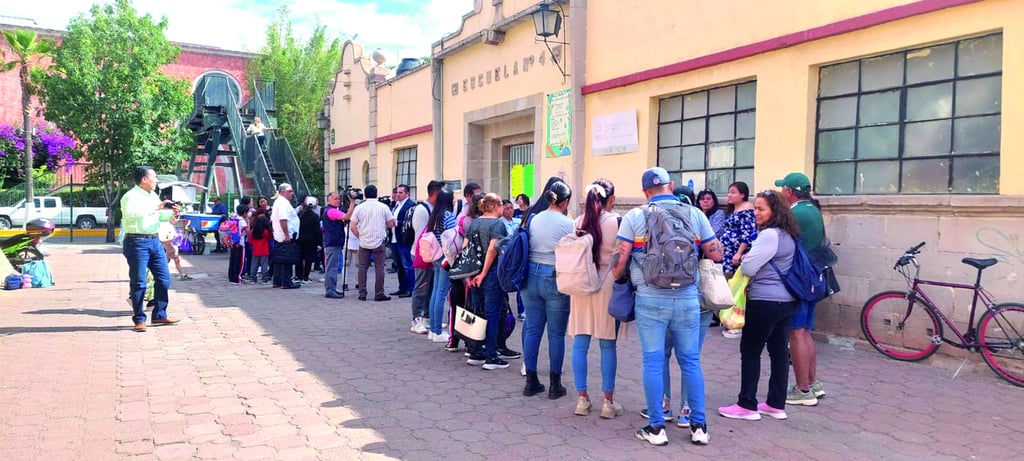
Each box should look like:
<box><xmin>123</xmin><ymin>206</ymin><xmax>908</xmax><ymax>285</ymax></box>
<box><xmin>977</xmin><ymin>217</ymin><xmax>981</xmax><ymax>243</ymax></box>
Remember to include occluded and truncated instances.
<box><xmin>327</xmin><ymin>0</ymin><xmax>1024</xmax><ymax>336</ymax></box>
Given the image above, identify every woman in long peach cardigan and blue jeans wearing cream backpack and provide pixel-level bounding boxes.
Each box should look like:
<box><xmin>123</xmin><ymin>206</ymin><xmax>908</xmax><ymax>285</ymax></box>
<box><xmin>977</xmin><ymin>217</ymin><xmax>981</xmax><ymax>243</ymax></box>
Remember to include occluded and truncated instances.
<box><xmin>568</xmin><ymin>178</ymin><xmax>623</xmax><ymax>419</ymax></box>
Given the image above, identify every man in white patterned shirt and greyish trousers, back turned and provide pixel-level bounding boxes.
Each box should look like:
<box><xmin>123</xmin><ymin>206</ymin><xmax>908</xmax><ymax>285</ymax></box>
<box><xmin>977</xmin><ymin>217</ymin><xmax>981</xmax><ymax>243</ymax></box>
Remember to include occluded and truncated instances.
<box><xmin>349</xmin><ymin>184</ymin><xmax>395</xmax><ymax>301</ymax></box>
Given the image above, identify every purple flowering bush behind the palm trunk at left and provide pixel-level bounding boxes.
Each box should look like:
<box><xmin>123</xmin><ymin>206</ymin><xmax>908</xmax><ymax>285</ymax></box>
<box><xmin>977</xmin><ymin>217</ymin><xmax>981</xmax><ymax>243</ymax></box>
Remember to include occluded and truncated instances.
<box><xmin>0</xmin><ymin>123</ymin><xmax>81</xmax><ymax>186</ymax></box>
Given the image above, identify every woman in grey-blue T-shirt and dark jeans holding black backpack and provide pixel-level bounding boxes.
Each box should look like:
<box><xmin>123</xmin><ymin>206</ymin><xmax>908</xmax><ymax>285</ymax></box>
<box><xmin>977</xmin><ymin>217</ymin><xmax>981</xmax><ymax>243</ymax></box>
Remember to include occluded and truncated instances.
<box><xmin>466</xmin><ymin>194</ymin><xmax>509</xmax><ymax>370</ymax></box>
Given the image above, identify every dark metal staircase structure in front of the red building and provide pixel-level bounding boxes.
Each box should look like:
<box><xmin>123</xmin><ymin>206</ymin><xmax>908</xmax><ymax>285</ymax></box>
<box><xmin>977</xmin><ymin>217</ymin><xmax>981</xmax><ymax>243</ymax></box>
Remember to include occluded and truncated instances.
<box><xmin>181</xmin><ymin>75</ymin><xmax>308</xmax><ymax>202</ymax></box>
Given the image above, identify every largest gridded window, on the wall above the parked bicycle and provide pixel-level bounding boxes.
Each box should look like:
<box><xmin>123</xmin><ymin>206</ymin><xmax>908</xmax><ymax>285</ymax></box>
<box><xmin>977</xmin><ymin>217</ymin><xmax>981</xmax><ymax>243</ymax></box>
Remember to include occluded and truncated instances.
<box><xmin>814</xmin><ymin>34</ymin><xmax>1002</xmax><ymax>195</ymax></box>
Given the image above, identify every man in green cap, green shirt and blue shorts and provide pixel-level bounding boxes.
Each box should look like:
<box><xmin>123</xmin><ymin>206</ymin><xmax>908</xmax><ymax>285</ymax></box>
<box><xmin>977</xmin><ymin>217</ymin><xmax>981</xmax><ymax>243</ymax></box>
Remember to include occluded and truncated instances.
<box><xmin>775</xmin><ymin>173</ymin><xmax>825</xmax><ymax>406</ymax></box>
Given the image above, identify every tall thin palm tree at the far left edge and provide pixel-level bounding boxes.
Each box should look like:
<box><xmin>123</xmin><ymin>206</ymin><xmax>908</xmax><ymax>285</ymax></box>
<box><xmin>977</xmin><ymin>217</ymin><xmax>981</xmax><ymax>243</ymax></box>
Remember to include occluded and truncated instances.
<box><xmin>0</xmin><ymin>31</ymin><xmax>56</xmax><ymax>224</ymax></box>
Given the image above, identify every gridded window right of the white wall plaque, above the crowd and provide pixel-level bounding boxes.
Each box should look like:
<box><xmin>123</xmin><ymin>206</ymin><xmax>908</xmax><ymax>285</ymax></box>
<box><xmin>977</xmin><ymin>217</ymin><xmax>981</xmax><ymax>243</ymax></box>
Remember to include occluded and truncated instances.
<box><xmin>657</xmin><ymin>82</ymin><xmax>757</xmax><ymax>195</ymax></box>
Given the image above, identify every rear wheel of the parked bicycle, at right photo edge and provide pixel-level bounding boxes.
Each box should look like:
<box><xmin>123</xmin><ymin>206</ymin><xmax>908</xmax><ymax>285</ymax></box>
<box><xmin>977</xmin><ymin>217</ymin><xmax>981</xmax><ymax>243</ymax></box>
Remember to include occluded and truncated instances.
<box><xmin>978</xmin><ymin>303</ymin><xmax>1024</xmax><ymax>387</ymax></box>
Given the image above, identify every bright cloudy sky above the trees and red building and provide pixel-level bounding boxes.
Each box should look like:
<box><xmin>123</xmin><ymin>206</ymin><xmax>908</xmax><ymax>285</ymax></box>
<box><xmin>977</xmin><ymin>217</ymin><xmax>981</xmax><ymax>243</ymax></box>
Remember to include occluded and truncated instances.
<box><xmin>0</xmin><ymin>0</ymin><xmax>473</xmax><ymax>60</ymax></box>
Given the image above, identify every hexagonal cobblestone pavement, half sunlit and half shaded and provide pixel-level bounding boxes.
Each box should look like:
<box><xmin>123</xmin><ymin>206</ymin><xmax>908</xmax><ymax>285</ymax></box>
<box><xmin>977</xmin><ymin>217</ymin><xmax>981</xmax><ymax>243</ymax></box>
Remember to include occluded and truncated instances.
<box><xmin>0</xmin><ymin>243</ymin><xmax>1024</xmax><ymax>460</ymax></box>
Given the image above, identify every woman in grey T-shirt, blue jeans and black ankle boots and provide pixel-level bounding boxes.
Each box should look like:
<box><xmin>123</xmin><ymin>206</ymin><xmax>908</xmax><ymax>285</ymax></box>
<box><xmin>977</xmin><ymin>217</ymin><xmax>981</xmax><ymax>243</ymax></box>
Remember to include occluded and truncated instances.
<box><xmin>522</xmin><ymin>180</ymin><xmax>573</xmax><ymax>400</ymax></box>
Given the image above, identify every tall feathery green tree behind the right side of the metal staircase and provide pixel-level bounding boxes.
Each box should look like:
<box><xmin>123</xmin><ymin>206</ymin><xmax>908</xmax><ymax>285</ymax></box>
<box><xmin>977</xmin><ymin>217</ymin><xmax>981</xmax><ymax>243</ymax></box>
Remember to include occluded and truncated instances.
<box><xmin>247</xmin><ymin>6</ymin><xmax>341</xmax><ymax>197</ymax></box>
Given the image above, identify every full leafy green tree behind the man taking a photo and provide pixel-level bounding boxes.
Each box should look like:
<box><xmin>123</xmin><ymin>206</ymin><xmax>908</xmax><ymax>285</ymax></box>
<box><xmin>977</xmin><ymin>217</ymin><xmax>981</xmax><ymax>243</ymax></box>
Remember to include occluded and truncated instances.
<box><xmin>39</xmin><ymin>0</ymin><xmax>195</xmax><ymax>242</ymax></box>
